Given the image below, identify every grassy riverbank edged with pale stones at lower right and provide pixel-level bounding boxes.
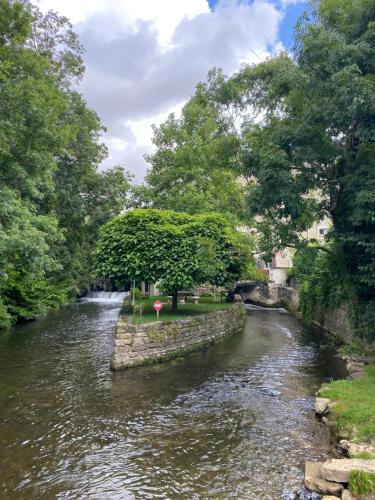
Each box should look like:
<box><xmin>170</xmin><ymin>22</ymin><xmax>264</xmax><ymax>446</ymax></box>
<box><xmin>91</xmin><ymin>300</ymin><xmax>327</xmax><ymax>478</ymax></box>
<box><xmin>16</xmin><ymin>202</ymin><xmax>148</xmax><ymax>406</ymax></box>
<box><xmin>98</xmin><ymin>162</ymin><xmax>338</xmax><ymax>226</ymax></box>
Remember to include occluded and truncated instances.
<box><xmin>305</xmin><ymin>357</ymin><xmax>375</xmax><ymax>500</ymax></box>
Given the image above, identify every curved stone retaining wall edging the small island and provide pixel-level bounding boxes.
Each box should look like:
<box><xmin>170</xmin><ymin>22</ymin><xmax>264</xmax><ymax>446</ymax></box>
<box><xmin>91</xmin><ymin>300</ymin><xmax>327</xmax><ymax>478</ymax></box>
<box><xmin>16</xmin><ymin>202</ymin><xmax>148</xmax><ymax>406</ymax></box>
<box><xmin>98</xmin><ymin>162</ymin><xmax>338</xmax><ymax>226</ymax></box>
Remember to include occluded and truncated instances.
<box><xmin>111</xmin><ymin>303</ymin><xmax>245</xmax><ymax>370</ymax></box>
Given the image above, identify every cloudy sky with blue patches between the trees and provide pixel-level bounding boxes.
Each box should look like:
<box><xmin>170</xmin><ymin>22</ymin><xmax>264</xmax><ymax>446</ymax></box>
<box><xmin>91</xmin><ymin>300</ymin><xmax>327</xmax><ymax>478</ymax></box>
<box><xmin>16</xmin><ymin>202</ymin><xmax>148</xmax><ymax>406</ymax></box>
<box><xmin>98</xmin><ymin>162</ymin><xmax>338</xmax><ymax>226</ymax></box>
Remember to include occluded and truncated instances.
<box><xmin>36</xmin><ymin>0</ymin><xmax>306</xmax><ymax>183</ymax></box>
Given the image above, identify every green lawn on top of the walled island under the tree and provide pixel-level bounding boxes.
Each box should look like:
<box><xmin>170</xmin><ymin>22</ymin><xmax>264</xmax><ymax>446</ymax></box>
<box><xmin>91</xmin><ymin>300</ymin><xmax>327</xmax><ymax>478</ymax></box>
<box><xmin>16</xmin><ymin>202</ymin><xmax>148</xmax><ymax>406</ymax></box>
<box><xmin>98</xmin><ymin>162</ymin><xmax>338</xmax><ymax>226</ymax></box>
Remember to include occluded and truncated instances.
<box><xmin>122</xmin><ymin>296</ymin><xmax>231</xmax><ymax>323</ymax></box>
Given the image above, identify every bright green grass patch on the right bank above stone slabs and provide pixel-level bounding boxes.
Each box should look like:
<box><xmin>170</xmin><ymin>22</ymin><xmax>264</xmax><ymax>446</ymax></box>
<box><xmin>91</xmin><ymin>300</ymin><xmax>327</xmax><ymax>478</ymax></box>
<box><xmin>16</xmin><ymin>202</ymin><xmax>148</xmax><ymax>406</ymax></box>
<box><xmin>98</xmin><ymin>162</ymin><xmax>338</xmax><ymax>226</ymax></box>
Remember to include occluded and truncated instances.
<box><xmin>320</xmin><ymin>365</ymin><xmax>375</xmax><ymax>441</ymax></box>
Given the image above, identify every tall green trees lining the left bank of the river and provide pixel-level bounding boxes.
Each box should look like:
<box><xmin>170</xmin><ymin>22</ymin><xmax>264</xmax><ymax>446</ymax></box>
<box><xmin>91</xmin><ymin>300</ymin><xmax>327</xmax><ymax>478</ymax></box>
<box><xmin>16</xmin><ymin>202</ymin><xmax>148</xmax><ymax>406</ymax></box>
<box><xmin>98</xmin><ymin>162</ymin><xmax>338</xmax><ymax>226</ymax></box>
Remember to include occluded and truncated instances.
<box><xmin>0</xmin><ymin>0</ymin><xmax>129</xmax><ymax>327</ymax></box>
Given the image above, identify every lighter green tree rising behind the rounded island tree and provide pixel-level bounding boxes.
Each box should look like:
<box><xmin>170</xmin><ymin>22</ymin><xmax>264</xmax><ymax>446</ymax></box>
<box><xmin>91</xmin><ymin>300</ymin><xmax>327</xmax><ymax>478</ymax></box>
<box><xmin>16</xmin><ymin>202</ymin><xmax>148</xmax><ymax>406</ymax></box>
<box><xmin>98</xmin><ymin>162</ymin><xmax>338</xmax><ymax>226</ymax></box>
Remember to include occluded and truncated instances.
<box><xmin>132</xmin><ymin>71</ymin><xmax>245</xmax><ymax>221</ymax></box>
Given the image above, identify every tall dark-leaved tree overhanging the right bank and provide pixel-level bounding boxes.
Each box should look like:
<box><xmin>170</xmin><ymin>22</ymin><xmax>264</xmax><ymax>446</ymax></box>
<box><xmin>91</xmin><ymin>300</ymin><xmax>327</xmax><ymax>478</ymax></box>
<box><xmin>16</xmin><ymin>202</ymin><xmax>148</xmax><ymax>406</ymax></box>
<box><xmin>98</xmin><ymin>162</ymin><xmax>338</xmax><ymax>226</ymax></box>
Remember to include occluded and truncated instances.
<box><xmin>222</xmin><ymin>0</ymin><xmax>375</xmax><ymax>336</ymax></box>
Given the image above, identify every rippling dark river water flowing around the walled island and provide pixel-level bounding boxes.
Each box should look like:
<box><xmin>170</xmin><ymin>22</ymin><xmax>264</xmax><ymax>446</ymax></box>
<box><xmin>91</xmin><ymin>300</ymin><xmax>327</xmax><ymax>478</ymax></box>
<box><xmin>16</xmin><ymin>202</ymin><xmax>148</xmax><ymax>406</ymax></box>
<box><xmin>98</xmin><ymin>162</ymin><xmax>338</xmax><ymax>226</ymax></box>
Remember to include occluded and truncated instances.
<box><xmin>0</xmin><ymin>299</ymin><xmax>344</xmax><ymax>500</ymax></box>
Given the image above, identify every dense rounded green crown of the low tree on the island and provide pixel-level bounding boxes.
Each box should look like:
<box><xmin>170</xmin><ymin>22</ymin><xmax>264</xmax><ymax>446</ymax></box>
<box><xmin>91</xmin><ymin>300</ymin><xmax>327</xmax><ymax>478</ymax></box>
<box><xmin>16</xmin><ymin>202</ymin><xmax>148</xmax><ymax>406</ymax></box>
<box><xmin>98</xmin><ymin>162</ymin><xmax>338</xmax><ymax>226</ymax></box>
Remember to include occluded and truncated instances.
<box><xmin>96</xmin><ymin>209</ymin><xmax>251</xmax><ymax>306</ymax></box>
